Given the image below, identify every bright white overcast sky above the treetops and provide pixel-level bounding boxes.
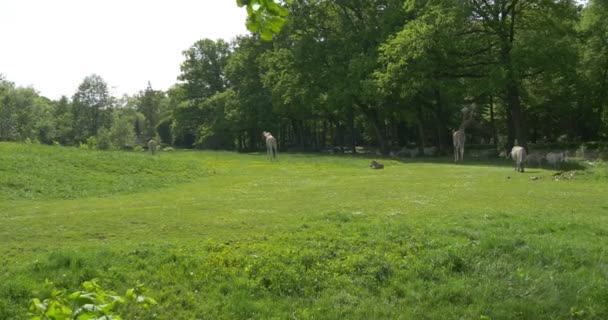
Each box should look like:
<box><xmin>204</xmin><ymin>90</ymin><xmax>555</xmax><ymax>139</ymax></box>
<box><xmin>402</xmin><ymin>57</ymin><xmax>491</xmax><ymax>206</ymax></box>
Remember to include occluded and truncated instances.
<box><xmin>0</xmin><ymin>0</ymin><xmax>248</xmax><ymax>99</ymax></box>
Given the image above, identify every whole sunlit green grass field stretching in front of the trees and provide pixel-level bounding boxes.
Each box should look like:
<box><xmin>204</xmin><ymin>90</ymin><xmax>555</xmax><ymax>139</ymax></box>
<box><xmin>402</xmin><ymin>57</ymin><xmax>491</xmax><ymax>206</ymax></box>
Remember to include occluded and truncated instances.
<box><xmin>0</xmin><ymin>143</ymin><xmax>608</xmax><ymax>319</ymax></box>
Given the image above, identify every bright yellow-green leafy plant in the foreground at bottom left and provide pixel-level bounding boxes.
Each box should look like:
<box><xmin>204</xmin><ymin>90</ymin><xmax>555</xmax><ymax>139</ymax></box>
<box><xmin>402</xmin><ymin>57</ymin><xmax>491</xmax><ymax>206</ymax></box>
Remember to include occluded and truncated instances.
<box><xmin>28</xmin><ymin>279</ymin><xmax>156</xmax><ymax>320</ymax></box>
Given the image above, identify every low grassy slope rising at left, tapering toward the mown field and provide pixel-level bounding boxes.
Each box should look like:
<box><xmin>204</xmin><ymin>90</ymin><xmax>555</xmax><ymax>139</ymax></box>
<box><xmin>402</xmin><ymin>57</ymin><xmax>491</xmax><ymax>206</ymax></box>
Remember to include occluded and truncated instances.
<box><xmin>0</xmin><ymin>143</ymin><xmax>210</xmax><ymax>200</ymax></box>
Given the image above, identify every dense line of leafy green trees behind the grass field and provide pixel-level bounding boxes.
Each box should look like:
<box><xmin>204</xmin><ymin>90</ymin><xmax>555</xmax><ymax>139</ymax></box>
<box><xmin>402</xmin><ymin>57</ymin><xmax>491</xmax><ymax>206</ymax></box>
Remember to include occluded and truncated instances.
<box><xmin>0</xmin><ymin>0</ymin><xmax>608</xmax><ymax>154</ymax></box>
